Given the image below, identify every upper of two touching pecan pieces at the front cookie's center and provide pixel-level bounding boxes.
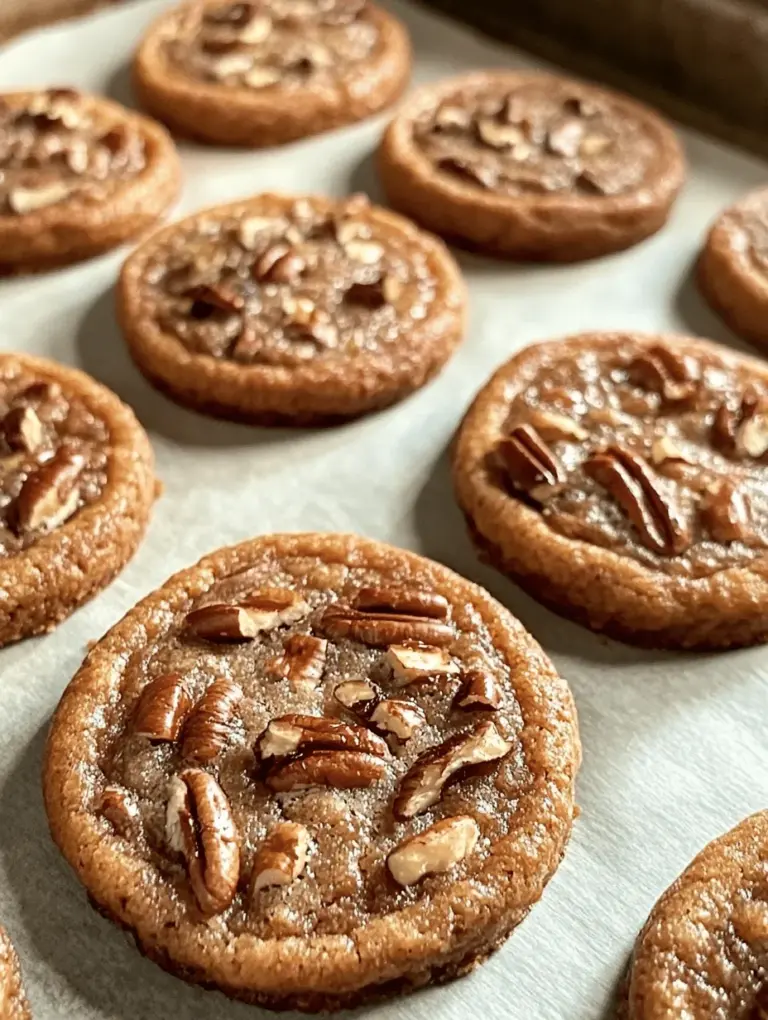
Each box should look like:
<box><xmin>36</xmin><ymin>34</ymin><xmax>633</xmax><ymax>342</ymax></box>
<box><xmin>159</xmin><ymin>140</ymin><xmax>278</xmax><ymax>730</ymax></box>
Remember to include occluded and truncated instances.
<box><xmin>256</xmin><ymin>713</ymin><xmax>390</xmax><ymax>761</ymax></box>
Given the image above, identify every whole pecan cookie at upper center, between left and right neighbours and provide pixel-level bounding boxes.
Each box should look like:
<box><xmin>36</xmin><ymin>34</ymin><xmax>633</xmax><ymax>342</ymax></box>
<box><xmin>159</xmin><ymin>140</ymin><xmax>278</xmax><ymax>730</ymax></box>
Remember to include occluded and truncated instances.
<box><xmin>118</xmin><ymin>195</ymin><xmax>466</xmax><ymax>424</ymax></box>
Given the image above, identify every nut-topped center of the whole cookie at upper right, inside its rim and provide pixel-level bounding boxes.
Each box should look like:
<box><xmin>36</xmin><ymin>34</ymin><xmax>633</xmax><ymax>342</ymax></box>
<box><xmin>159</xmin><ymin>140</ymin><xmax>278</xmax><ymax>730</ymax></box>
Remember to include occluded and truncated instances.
<box><xmin>413</xmin><ymin>80</ymin><xmax>657</xmax><ymax>197</ymax></box>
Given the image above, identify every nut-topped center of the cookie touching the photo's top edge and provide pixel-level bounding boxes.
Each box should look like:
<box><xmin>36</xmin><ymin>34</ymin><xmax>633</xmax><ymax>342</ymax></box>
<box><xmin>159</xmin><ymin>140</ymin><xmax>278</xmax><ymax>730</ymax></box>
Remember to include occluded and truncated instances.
<box><xmin>166</xmin><ymin>0</ymin><xmax>379</xmax><ymax>92</ymax></box>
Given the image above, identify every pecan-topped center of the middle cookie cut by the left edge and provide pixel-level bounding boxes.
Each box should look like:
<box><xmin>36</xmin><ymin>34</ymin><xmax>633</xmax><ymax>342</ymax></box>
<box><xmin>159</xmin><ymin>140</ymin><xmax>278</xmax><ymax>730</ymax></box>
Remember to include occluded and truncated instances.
<box><xmin>0</xmin><ymin>368</ymin><xmax>108</xmax><ymax>557</ymax></box>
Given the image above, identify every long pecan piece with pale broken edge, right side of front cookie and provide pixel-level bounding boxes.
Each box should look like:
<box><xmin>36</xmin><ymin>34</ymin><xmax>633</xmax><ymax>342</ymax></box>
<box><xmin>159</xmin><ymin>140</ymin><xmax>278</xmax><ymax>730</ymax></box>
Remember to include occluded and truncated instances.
<box><xmin>393</xmin><ymin>722</ymin><xmax>512</xmax><ymax>820</ymax></box>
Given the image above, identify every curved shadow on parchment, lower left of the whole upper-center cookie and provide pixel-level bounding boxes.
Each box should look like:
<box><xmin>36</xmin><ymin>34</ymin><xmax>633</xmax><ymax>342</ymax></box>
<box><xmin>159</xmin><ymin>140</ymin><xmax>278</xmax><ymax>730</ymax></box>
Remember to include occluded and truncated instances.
<box><xmin>76</xmin><ymin>287</ymin><xmax>307</xmax><ymax>449</ymax></box>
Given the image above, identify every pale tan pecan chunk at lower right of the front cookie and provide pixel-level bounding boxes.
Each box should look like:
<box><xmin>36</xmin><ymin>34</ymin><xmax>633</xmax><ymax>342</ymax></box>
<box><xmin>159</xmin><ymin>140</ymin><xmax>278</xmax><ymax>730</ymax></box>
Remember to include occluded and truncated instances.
<box><xmin>387</xmin><ymin>815</ymin><xmax>480</xmax><ymax>885</ymax></box>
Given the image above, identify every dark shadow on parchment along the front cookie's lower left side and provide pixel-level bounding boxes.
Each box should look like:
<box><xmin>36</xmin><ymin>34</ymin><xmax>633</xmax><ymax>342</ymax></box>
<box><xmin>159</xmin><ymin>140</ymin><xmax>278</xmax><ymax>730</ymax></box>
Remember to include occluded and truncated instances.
<box><xmin>0</xmin><ymin>725</ymin><xmax>289</xmax><ymax>1020</ymax></box>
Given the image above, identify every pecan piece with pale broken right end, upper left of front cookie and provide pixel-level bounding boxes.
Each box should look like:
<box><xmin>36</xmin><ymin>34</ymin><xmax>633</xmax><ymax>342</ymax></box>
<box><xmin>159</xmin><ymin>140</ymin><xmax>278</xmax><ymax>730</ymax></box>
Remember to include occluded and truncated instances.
<box><xmin>186</xmin><ymin>589</ymin><xmax>309</xmax><ymax>642</ymax></box>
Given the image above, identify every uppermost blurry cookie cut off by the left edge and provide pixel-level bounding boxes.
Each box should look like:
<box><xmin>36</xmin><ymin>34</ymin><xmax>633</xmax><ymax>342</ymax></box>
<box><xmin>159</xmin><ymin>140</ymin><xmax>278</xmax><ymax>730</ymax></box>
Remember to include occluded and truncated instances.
<box><xmin>0</xmin><ymin>89</ymin><xmax>181</xmax><ymax>274</ymax></box>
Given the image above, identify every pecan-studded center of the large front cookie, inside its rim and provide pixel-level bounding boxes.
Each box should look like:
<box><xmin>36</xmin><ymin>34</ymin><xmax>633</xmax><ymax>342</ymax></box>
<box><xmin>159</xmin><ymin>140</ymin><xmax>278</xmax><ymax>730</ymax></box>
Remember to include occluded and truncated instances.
<box><xmin>94</xmin><ymin>557</ymin><xmax>529</xmax><ymax>937</ymax></box>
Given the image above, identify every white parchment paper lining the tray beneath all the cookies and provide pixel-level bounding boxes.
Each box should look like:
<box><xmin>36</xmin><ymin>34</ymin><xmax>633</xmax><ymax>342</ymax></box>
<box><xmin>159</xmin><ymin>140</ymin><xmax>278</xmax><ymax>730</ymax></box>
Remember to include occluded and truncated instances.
<box><xmin>0</xmin><ymin>0</ymin><xmax>768</xmax><ymax>1020</ymax></box>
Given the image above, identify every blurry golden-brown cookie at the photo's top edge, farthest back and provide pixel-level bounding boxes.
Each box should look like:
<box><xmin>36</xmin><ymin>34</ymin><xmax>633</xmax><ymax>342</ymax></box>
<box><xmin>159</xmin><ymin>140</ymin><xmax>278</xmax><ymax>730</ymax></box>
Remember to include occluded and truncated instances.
<box><xmin>134</xmin><ymin>0</ymin><xmax>411</xmax><ymax>147</ymax></box>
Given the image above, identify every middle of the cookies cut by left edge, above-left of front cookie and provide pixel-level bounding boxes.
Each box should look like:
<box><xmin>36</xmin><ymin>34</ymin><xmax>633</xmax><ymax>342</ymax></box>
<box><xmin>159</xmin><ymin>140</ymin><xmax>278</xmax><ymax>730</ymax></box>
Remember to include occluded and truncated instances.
<box><xmin>0</xmin><ymin>354</ymin><xmax>155</xmax><ymax>645</ymax></box>
